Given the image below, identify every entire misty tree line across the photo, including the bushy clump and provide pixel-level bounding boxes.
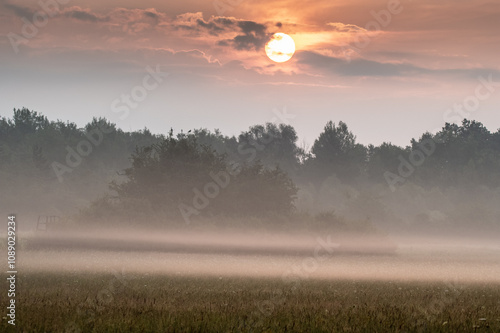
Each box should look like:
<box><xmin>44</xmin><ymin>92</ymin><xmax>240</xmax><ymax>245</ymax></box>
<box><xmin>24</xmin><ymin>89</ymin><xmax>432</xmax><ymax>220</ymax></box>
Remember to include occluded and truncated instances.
<box><xmin>0</xmin><ymin>108</ymin><xmax>500</xmax><ymax>227</ymax></box>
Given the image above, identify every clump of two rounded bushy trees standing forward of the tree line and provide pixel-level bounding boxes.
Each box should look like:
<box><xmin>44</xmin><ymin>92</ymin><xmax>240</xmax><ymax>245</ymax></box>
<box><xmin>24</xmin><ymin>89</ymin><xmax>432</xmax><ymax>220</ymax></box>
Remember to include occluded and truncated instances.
<box><xmin>111</xmin><ymin>131</ymin><xmax>297</xmax><ymax>220</ymax></box>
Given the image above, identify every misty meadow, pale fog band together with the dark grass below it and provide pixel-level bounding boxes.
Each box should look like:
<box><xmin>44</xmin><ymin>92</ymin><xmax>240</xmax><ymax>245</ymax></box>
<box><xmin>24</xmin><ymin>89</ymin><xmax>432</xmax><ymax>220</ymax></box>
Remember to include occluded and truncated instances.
<box><xmin>0</xmin><ymin>228</ymin><xmax>500</xmax><ymax>332</ymax></box>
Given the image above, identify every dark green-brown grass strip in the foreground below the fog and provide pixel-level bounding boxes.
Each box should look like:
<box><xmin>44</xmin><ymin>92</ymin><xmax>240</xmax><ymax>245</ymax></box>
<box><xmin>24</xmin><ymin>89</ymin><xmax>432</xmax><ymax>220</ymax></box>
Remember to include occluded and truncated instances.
<box><xmin>0</xmin><ymin>273</ymin><xmax>500</xmax><ymax>332</ymax></box>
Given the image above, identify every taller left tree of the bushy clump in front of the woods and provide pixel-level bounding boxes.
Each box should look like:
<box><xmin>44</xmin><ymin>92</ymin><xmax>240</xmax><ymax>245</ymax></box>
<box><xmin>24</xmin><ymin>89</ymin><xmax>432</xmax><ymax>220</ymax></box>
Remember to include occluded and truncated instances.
<box><xmin>111</xmin><ymin>131</ymin><xmax>225</xmax><ymax>208</ymax></box>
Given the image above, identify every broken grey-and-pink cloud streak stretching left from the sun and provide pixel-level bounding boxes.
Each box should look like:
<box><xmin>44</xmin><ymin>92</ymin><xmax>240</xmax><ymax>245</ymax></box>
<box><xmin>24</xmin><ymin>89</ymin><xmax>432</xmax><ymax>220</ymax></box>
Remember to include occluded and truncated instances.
<box><xmin>0</xmin><ymin>4</ymin><xmax>275</xmax><ymax>51</ymax></box>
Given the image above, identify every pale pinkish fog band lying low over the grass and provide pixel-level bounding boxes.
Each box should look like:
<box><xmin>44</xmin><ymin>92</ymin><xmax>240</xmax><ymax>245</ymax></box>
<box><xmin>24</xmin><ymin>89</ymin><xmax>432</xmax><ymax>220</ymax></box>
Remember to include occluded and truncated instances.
<box><xmin>6</xmin><ymin>230</ymin><xmax>500</xmax><ymax>284</ymax></box>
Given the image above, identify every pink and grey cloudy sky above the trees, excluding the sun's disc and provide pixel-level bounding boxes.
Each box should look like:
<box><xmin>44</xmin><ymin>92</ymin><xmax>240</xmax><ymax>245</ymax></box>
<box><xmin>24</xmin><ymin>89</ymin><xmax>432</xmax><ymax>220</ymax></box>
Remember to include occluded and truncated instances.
<box><xmin>0</xmin><ymin>0</ymin><xmax>500</xmax><ymax>147</ymax></box>
